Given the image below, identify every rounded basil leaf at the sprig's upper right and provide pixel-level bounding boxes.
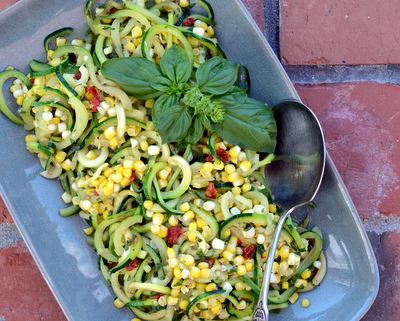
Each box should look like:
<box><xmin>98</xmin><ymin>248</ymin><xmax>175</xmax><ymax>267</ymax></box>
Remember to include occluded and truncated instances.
<box><xmin>196</xmin><ymin>57</ymin><xmax>237</xmax><ymax>95</ymax></box>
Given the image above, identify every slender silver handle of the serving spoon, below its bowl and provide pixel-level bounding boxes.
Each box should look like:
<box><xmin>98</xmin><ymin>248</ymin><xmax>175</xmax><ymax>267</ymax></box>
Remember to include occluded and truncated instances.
<box><xmin>252</xmin><ymin>209</ymin><xmax>293</xmax><ymax>321</ymax></box>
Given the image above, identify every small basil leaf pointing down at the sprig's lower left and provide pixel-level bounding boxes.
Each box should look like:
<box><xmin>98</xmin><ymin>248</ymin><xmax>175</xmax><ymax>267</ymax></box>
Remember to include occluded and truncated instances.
<box><xmin>154</xmin><ymin>104</ymin><xmax>193</xmax><ymax>144</ymax></box>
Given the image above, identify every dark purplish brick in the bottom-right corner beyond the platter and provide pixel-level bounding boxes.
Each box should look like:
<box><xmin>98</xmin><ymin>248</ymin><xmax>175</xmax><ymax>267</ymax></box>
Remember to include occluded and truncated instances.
<box><xmin>362</xmin><ymin>232</ymin><xmax>400</xmax><ymax>321</ymax></box>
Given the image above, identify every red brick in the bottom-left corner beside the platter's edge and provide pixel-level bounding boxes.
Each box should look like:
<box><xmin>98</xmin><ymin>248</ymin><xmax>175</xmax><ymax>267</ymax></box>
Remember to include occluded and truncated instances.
<box><xmin>0</xmin><ymin>241</ymin><xmax>66</xmax><ymax>321</ymax></box>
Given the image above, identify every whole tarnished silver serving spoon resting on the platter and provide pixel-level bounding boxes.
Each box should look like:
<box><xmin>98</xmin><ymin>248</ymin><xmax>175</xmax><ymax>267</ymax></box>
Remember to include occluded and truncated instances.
<box><xmin>253</xmin><ymin>101</ymin><xmax>326</xmax><ymax>321</ymax></box>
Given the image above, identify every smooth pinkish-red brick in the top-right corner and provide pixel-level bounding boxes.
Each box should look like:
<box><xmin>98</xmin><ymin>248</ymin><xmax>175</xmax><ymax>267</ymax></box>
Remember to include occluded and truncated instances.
<box><xmin>280</xmin><ymin>0</ymin><xmax>400</xmax><ymax>65</ymax></box>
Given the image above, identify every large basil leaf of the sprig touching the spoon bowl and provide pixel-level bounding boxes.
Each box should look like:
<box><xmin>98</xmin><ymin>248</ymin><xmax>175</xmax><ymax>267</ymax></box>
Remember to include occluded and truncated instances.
<box><xmin>211</xmin><ymin>89</ymin><xmax>277</xmax><ymax>153</ymax></box>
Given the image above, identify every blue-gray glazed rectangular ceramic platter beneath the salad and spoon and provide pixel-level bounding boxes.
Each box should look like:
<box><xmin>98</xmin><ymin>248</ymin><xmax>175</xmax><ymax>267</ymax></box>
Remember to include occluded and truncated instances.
<box><xmin>0</xmin><ymin>0</ymin><xmax>379</xmax><ymax>321</ymax></box>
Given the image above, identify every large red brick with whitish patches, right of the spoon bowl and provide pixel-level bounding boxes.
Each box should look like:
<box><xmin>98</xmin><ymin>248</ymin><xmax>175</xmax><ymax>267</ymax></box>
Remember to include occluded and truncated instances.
<box><xmin>296</xmin><ymin>83</ymin><xmax>400</xmax><ymax>218</ymax></box>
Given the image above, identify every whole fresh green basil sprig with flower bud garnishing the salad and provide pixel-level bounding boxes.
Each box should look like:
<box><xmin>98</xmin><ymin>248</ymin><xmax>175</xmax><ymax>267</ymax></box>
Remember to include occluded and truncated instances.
<box><xmin>101</xmin><ymin>46</ymin><xmax>276</xmax><ymax>153</ymax></box>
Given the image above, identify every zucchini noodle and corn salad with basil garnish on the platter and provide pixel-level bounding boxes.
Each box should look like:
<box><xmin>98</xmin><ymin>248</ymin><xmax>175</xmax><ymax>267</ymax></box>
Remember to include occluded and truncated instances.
<box><xmin>0</xmin><ymin>0</ymin><xmax>326</xmax><ymax>321</ymax></box>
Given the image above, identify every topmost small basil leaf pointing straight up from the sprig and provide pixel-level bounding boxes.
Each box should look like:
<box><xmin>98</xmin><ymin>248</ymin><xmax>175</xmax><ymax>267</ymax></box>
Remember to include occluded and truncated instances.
<box><xmin>160</xmin><ymin>46</ymin><xmax>192</xmax><ymax>84</ymax></box>
